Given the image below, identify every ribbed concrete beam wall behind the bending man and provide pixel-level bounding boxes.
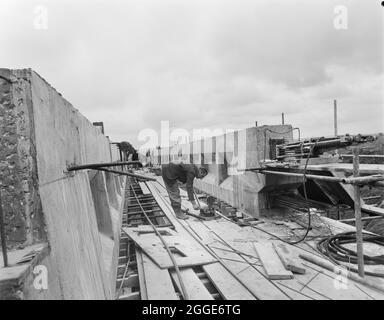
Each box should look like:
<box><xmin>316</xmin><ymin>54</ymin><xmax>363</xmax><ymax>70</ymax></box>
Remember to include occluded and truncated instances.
<box><xmin>151</xmin><ymin>125</ymin><xmax>293</xmax><ymax>217</ymax></box>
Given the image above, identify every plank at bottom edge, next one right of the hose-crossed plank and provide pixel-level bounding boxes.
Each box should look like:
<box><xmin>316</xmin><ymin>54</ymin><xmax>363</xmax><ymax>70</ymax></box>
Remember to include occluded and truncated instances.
<box><xmin>203</xmin><ymin>263</ymin><xmax>256</xmax><ymax>300</ymax></box>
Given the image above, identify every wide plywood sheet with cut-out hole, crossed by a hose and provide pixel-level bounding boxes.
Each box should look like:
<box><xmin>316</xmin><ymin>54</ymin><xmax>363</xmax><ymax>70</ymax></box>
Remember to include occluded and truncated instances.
<box><xmin>123</xmin><ymin>227</ymin><xmax>216</xmax><ymax>269</ymax></box>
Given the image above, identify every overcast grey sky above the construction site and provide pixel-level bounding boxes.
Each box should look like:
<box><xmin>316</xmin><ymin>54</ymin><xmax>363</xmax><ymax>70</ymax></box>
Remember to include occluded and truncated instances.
<box><xmin>0</xmin><ymin>0</ymin><xmax>384</xmax><ymax>146</ymax></box>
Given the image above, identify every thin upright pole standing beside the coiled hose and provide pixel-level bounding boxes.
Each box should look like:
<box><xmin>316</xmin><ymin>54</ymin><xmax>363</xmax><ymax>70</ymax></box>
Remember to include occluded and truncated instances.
<box><xmin>353</xmin><ymin>148</ymin><xmax>364</xmax><ymax>278</ymax></box>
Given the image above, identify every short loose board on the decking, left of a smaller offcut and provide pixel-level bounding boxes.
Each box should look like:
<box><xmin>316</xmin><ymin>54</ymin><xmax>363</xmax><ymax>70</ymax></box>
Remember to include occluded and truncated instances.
<box><xmin>253</xmin><ymin>242</ymin><xmax>293</xmax><ymax>280</ymax></box>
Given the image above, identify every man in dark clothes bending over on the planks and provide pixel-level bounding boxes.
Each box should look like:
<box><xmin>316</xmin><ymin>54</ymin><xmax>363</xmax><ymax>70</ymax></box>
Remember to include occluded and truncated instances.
<box><xmin>161</xmin><ymin>163</ymin><xmax>208</xmax><ymax>219</ymax></box>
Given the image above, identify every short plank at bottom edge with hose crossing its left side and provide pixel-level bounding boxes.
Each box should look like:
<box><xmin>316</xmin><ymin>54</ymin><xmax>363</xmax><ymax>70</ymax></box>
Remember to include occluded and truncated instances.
<box><xmin>171</xmin><ymin>268</ymin><xmax>214</xmax><ymax>300</ymax></box>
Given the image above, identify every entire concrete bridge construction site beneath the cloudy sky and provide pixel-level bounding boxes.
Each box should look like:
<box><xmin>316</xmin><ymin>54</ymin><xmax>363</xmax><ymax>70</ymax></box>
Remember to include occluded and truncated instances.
<box><xmin>0</xmin><ymin>69</ymin><xmax>384</xmax><ymax>300</ymax></box>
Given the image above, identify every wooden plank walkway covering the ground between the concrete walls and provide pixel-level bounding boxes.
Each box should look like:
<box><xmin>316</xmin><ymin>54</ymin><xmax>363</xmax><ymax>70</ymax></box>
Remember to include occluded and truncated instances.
<box><xmin>123</xmin><ymin>177</ymin><xmax>384</xmax><ymax>300</ymax></box>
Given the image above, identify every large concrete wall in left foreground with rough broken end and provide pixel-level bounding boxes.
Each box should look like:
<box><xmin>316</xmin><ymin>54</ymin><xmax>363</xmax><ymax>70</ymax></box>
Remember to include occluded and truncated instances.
<box><xmin>0</xmin><ymin>69</ymin><xmax>124</xmax><ymax>299</ymax></box>
